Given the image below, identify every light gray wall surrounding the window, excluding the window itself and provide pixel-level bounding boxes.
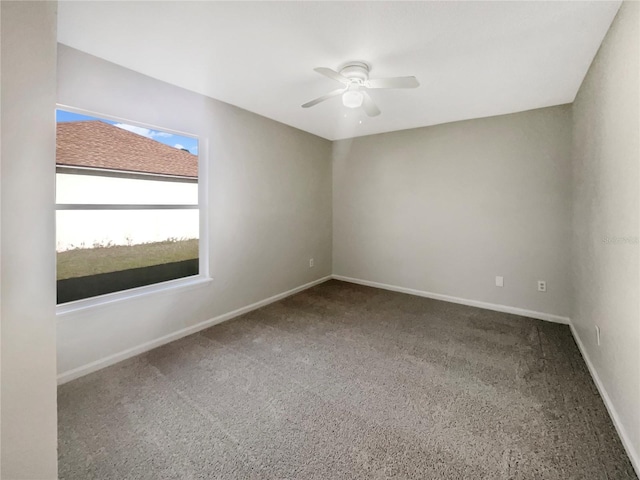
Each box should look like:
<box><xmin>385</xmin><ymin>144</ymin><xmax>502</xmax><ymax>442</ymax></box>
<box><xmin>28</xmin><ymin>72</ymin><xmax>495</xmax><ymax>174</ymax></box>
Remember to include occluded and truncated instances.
<box><xmin>55</xmin><ymin>45</ymin><xmax>332</xmax><ymax>378</ymax></box>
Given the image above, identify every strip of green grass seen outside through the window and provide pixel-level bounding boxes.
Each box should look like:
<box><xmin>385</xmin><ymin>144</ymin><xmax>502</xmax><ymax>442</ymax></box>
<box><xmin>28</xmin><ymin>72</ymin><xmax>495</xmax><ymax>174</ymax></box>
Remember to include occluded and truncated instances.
<box><xmin>57</xmin><ymin>239</ymin><xmax>198</xmax><ymax>280</ymax></box>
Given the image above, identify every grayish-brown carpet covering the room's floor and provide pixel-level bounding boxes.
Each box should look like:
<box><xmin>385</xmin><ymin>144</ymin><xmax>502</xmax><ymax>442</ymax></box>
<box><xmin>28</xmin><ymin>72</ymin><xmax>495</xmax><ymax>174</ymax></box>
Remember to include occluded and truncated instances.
<box><xmin>58</xmin><ymin>280</ymin><xmax>636</xmax><ymax>480</ymax></box>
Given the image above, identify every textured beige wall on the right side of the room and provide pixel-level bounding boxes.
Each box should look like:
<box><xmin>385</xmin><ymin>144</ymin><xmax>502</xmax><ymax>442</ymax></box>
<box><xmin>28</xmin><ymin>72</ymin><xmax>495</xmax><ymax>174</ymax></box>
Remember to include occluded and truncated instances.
<box><xmin>572</xmin><ymin>2</ymin><xmax>640</xmax><ymax>470</ymax></box>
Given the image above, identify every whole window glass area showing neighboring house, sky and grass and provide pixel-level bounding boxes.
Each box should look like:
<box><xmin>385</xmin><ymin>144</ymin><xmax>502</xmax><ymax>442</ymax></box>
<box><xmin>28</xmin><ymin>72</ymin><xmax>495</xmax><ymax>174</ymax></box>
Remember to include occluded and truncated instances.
<box><xmin>56</xmin><ymin>109</ymin><xmax>200</xmax><ymax>304</ymax></box>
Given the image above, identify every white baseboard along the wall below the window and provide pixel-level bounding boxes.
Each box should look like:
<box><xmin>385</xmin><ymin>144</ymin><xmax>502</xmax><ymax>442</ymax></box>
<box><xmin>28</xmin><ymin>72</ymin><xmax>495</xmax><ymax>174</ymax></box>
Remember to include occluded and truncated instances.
<box><xmin>58</xmin><ymin>275</ymin><xmax>331</xmax><ymax>385</ymax></box>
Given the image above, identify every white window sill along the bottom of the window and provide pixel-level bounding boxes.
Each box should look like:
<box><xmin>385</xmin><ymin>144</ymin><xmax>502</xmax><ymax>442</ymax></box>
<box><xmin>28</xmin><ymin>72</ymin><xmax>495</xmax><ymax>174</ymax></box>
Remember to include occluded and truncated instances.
<box><xmin>56</xmin><ymin>275</ymin><xmax>213</xmax><ymax>318</ymax></box>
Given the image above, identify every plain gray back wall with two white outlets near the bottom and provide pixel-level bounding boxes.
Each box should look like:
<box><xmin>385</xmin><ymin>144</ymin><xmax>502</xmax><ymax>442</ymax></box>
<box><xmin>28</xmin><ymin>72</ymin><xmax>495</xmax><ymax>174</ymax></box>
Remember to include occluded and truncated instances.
<box><xmin>333</xmin><ymin>106</ymin><xmax>571</xmax><ymax>316</ymax></box>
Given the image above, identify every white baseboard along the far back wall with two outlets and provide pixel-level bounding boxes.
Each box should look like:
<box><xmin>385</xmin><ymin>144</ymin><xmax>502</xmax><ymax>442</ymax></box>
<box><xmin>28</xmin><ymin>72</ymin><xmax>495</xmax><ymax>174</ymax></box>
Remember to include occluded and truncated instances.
<box><xmin>332</xmin><ymin>275</ymin><xmax>571</xmax><ymax>325</ymax></box>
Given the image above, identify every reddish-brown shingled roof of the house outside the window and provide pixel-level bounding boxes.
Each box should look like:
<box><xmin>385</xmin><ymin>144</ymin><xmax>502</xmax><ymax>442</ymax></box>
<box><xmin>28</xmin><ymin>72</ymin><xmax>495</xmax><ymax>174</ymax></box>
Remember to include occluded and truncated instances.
<box><xmin>56</xmin><ymin>120</ymin><xmax>198</xmax><ymax>178</ymax></box>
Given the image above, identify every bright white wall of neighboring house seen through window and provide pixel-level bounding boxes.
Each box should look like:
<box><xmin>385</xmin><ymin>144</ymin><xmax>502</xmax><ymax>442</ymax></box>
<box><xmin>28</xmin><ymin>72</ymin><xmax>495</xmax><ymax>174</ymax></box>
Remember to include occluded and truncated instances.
<box><xmin>56</xmin><ymin>173</ymin><xmax>199</xmax><ymax>251</ymax></box>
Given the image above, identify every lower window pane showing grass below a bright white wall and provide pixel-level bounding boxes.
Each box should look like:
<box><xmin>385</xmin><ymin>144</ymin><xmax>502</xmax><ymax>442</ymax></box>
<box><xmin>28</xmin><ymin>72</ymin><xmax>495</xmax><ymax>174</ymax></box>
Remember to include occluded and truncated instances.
<box><xmin>56</xmin><ymin>210</ymin><xmax>199</xmax><ymax>303</ymax></box>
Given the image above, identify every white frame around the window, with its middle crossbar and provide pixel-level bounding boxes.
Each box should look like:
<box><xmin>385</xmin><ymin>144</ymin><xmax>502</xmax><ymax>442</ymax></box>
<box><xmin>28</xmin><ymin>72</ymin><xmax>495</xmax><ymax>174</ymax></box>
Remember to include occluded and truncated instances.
<box><xmin>55</xmin><ymin>104</ymin><xmax>213</xmax><ymax>316</ymax></box>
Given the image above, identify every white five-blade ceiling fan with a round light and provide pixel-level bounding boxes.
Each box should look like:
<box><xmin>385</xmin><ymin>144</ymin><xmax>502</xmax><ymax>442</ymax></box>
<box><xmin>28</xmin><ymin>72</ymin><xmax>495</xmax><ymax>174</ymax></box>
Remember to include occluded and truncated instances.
<box><xmin>302</xmin><ymin>62</ymin><xmax>420</xmax><ymax>117</ymax></box>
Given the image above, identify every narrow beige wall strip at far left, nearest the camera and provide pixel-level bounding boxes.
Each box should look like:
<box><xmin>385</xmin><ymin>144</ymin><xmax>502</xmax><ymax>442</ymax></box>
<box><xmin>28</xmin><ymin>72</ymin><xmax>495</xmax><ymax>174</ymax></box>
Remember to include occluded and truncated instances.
<box><xmin>0</xmin><ymin>2</ymin><xmax>57</xmax><ymax>480</ymax></box>
